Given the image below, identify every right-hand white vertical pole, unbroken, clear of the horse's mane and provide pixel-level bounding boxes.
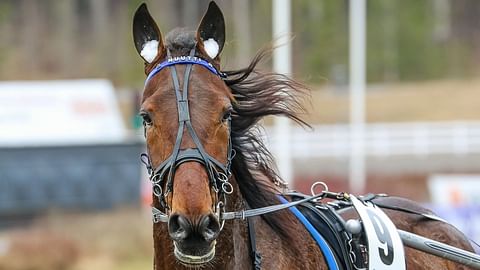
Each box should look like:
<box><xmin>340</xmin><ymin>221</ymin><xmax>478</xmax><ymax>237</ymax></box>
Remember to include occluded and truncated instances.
<box><xmin>349</xmin><ymin>0</ymin><xmax>366</xmax><ymax>193</ymax></box>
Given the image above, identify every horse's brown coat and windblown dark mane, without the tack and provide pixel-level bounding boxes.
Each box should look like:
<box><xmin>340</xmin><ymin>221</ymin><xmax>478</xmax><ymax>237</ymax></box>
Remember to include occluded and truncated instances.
<box><xmin>142</xmin><ymin>23</ymin><xmax>472</xmax><ymax>270</ymax></box>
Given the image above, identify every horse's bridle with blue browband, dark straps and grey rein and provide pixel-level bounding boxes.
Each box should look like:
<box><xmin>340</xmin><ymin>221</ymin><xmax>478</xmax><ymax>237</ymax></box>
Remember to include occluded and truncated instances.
<box><xmin>141</xmin><ymin>48</ymin><xmax>327</xmax><ymax>228</ymax></box>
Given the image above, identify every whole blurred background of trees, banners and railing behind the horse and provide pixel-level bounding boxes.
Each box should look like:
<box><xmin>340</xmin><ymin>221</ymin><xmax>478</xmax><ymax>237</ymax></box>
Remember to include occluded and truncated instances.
<box><xmin>0</xmin><ymin>0</ymin><xmax>480</xmax><ymax>270</ymax></box>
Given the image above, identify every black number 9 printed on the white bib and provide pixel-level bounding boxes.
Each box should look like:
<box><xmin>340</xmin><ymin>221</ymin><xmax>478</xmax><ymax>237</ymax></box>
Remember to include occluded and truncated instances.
<box><xmin>367</xmin><ymin>209</ymin><xmax>393</xmax><ymax>265</ymax></box>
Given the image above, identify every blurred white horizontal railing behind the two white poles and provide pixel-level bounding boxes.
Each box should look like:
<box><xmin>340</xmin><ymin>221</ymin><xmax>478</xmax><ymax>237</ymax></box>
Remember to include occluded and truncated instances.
<box><xmin>266</xmin><ymin>121</ymin><xmax>480</xmax><ymax>158</ymax></box>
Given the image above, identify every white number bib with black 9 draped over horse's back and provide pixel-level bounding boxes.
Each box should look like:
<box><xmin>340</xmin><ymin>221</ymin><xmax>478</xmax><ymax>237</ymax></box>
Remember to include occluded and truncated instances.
<box><xmin>350</xmin><ymin>195</ymin><xmax>406</xmax><ymax>270</ymax></box>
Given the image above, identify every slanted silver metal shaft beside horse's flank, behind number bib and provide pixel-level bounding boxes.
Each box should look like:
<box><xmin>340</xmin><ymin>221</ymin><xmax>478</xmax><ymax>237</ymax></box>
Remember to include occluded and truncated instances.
<box><xmin>397</xmin><ymin>230</ymin><xmax>480</xmax><ymax>269</ymax></box>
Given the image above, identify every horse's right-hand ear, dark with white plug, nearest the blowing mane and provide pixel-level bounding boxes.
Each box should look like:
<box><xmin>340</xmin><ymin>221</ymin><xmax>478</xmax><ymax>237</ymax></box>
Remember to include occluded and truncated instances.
<box><xmin>197</xmin><ymin>1</ymin><xmax>225</xmax><ymax>59</ymax></box>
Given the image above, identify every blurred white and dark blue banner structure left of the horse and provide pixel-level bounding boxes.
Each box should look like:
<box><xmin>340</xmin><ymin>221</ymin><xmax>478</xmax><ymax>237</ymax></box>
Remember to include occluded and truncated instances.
<box><xmin>0</xmin><ymin>80</ymin><xmax>144</xmax><ymax>214</ymax></box>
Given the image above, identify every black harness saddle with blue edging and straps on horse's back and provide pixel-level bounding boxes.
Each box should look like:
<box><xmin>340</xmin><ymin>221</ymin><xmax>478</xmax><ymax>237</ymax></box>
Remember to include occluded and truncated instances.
<box><xmin>279</xmin><ymin>190</ymin><xmax>446</xmax><ymax>270</ymax></box>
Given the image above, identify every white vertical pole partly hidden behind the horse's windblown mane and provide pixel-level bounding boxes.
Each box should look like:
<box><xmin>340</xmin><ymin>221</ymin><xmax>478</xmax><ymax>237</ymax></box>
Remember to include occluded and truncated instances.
<box><xmin>272</xmin><ymin>0</ymin><xmax>293</xmax><ymax>183</ymax></box>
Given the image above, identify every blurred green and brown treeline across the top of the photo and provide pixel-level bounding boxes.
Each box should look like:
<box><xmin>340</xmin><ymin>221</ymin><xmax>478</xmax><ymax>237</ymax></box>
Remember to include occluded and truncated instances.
<box><xmin>0</xmin><ymin>0</ymin><xmax>480</xmax><ymax>87</ymax></box>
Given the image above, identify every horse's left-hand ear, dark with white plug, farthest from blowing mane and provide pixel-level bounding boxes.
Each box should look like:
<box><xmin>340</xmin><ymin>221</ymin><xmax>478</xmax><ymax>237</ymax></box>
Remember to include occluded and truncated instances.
<box><xmin>133</xmin><ymin>3</ymin><xmax>164</xmax><ymax>63</ymax></box>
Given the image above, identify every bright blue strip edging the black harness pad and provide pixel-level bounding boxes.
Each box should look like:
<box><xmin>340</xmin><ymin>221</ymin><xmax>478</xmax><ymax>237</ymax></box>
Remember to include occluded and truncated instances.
<box><xmin>278</xmin><ymin>195</ymin><xmax>340</xmax><ymax>270</ymax></box>
